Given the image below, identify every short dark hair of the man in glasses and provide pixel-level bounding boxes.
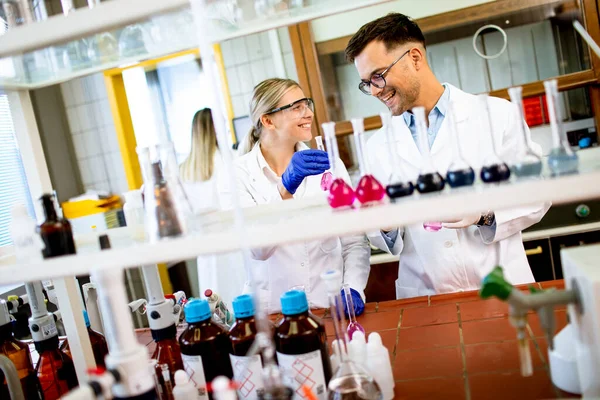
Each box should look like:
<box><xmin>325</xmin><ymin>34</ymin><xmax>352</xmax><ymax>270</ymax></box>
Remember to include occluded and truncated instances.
<box><xmin>346</xmin><ymin>13</ymin><xmax>425</xmax><ymax>63</ymax></box>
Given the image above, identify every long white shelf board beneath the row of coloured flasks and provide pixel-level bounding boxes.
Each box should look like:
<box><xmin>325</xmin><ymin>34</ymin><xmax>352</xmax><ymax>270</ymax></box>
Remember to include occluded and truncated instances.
<box><xmin>0</xmin><ymin>148</ymin><xmax>600</xmax><ymax>284</ymax></box>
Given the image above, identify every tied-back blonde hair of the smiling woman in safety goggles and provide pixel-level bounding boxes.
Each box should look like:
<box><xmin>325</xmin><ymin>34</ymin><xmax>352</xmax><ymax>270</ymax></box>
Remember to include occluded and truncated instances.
<box><xmin>238</xmin><ymin>78</ymin><xmax>300</xmax><ymax>155</ymax></box>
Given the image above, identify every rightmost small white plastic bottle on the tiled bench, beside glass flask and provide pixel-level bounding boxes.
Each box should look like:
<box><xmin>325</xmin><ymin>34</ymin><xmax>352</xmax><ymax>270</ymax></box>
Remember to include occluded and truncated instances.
<box><xmin>366</xmin><ymin>332</ymin><xmax>395</xmax><ymax>400</ymax></box>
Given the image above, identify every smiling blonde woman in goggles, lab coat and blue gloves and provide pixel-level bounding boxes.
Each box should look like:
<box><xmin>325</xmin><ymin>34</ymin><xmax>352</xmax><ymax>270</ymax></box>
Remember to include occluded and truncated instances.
<box><xmin>221</xmin><ymin>79</ymin><xmax>370</xmax><ymax>312</ymax></box>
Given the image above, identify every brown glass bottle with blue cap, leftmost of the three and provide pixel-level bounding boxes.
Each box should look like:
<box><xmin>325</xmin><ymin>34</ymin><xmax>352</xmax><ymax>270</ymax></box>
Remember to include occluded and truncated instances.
<box><xmin>179</xmin><ymin>299</ymin><xmax>233</xmax><ymax>399</ymax></box>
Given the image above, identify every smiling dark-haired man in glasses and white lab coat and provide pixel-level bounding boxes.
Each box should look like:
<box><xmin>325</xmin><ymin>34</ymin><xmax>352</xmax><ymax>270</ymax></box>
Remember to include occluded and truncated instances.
<box><xmin>346</xmin><ymin>13</ymin><xmax>550</xmax><ymax>298</ymax></box>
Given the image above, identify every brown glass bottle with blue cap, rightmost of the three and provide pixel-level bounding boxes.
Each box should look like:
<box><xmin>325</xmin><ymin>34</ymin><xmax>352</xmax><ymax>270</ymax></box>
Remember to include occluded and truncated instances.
<box><xmin>275</xmin><ymin>290</ymin><xmax>331</xmax><ymax>400</ymax></box>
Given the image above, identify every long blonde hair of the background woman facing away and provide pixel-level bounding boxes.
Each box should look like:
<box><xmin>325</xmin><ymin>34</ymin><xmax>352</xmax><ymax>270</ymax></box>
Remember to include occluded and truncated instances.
<box><xmin>179</xmin><ymin>108</ymin><xmax>218</xmax><ymax>182</ymax></box>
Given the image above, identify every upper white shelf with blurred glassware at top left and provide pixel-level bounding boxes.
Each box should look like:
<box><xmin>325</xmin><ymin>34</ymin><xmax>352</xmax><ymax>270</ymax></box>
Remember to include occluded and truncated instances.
<box><xmin>0</xmin><ymin>0</ymin><xmax>390</xmax><ymax>89</ymax></box>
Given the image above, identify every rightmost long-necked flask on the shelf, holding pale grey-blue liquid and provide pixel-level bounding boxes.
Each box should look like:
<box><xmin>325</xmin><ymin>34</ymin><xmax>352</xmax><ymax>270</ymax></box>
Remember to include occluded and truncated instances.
<box><xmin>544</xmin><ymin>79</ymin><xmax>579</xmax><ymax>175</ymax></box>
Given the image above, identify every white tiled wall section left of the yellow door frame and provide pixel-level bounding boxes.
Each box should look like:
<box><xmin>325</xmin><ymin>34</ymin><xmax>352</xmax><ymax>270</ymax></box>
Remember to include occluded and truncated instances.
<box><xmin>61</xmin><ymin>74</ymin><xmax>128</xmax><ymax>193</ymax></box>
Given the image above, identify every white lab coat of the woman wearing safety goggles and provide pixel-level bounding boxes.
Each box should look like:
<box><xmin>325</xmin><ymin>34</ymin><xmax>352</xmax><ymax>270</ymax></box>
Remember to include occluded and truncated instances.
<box><xmin>221</xmin><ymin>143</ymin><xmax>371</xmax><ymax>313</ymax></box>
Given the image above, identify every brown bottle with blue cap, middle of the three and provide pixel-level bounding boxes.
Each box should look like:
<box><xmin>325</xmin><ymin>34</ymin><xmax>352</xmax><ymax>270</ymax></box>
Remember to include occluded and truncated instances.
<box><xmin>229</xmin><ymin>294</ymin><xmax>264</xmax><ymax>399</ymax></box>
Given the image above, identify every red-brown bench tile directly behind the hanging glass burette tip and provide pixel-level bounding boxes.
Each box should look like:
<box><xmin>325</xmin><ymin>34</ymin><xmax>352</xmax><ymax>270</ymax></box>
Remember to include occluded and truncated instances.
<box><xmin>465</xmin><ymin>340</ymin><xmax>544</xmax><ymax>374</ymax></box>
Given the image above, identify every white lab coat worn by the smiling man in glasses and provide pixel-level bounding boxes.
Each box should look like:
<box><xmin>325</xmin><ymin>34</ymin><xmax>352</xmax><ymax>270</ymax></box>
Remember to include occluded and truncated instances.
<box><xmin>367</xmin><ymin>85</ymin><xmax>550</xmax><ymax>299</ymax></box>
